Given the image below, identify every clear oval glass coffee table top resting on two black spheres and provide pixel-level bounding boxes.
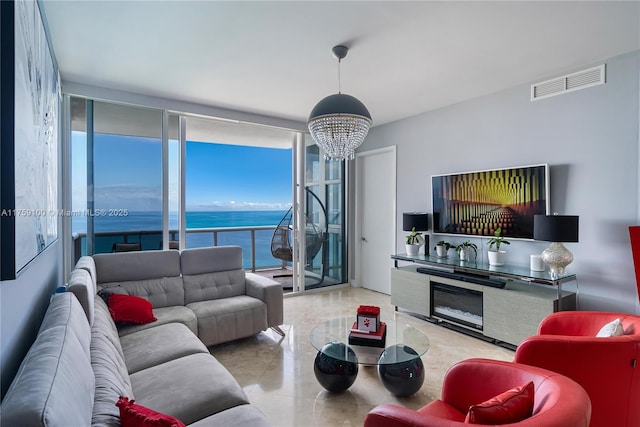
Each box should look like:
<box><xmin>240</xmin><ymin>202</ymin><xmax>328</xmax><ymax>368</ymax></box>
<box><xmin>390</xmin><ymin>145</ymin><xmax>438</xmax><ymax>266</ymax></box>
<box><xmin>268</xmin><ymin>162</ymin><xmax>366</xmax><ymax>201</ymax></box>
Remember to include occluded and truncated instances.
<box><xmin>309</xmin><ymin>316</ymin><xmax>429</xmax><ymax>365</ymax></box>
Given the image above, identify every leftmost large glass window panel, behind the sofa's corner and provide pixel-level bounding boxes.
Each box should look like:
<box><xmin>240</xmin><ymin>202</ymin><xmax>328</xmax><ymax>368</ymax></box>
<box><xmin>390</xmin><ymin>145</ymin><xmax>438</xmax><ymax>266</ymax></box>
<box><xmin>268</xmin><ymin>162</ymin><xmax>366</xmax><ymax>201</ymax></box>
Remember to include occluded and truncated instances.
<box><xmin>71</xmin><ymin>98</ymin><xmax>162</xmax><ymax>259</ymax></box>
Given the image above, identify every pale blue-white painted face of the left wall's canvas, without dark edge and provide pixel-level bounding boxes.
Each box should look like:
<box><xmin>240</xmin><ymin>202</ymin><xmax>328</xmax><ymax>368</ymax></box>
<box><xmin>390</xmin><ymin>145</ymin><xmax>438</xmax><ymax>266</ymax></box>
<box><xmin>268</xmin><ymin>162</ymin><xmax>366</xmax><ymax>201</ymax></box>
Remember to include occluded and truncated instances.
<box><xmin>12</xmin><ymin>1</ymin><xmax>60</xmax><ymax>272</ymax></box>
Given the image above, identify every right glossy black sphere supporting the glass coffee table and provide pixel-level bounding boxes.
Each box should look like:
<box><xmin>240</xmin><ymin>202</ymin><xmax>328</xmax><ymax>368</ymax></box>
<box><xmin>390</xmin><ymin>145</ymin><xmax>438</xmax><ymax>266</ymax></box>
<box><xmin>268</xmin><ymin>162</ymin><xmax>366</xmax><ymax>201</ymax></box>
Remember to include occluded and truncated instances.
<box><xmin>378</xmin><ymin>344</ymin><xmax>424</xmax><ymax>397</ymax></box>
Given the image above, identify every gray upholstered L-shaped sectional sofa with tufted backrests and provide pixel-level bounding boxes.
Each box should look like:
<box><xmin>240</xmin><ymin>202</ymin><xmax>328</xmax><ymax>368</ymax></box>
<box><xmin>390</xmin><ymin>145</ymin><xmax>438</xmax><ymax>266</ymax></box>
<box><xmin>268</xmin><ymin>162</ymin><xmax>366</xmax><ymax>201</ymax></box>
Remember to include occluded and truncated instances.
<box><xmin>0</xmin><ymin>247</ymin><xmax>282</xmax><ymax>427</ymax></box>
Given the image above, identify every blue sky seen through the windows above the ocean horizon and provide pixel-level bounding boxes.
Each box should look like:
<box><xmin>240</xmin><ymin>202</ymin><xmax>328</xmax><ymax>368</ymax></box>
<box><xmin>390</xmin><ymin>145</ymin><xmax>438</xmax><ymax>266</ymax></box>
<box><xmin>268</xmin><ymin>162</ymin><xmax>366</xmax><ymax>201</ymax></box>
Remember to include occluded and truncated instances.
<box><xmin>72</xmin><ymin>132</ymin><xmax>292</xmax><ymax>211</ymax></box>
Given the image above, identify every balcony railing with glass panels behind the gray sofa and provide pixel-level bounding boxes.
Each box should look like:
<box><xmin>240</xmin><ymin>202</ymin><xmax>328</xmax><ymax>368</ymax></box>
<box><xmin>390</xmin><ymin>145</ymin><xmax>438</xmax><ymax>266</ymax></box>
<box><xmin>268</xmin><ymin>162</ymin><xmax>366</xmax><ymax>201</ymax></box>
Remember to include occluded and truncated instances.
<box><xmin>73</xmin><ymin>225</ymin><xmax>287</xmax><ymax>271</ymax></box>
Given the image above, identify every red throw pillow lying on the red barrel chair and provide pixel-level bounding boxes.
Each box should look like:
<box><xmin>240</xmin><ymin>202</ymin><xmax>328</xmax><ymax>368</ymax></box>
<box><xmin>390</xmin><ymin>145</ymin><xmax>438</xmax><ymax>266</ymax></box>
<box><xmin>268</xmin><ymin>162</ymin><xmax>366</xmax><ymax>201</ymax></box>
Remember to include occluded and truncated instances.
<box><xmin>464</xmin><ymin>381</ymin><xmax>534</xmax><ymax>425</ymax></box>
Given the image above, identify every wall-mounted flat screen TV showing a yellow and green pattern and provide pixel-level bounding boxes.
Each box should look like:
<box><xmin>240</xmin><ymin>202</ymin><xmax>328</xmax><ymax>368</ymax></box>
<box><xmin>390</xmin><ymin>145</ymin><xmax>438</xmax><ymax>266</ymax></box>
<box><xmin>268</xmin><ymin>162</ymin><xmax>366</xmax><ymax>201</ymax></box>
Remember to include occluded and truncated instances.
<box><xmin>431</xmin><ymin>164</ymin><xmax>549</xmax><ymax>239</ymax></box>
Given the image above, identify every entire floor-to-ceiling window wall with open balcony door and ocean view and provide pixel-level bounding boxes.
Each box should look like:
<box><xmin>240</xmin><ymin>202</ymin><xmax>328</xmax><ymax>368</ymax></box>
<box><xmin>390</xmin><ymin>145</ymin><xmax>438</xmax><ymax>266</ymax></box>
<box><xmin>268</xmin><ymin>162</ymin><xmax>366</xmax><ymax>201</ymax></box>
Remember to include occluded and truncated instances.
<box><xmin>70</xmin><ymin>96</ymin><xmax>346</xmax><ymax>290</ymax></box>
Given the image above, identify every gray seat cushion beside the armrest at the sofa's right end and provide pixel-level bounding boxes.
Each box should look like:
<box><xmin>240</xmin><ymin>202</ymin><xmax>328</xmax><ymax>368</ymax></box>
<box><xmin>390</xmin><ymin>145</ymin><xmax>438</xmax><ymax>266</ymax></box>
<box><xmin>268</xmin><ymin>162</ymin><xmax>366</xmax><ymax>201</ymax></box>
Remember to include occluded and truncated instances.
<box><xmin>187</xmin><ymin>295</ymin><xmax>269</xmax><ymax>346</ymax></box>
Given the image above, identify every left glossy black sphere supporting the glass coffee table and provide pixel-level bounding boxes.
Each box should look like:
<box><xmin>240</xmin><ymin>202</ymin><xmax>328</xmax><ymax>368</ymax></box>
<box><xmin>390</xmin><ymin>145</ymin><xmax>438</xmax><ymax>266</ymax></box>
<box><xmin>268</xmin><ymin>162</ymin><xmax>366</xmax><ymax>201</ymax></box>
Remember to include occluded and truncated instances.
<box><xmin>313</xmin><ymin>342</ymin><xmax>358</xmax><ymax>393</ymax></box>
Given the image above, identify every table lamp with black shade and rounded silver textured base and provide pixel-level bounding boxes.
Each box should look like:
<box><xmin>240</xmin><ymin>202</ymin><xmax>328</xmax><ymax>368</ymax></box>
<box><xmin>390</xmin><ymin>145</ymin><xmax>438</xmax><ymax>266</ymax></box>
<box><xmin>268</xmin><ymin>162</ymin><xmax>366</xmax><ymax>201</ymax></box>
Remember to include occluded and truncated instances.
<box><xmin>533</xmin><ymin>214</ymin><xmax>578</xmax><ymax>279</ymax></box>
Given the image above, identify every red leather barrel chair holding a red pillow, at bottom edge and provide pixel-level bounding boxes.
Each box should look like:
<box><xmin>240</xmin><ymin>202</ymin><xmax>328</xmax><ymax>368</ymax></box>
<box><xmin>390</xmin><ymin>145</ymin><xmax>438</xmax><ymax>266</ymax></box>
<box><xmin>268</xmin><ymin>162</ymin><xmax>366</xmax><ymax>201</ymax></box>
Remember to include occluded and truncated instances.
<box><xmin>364</xmin><ymin>359</ymin><xmax>591</xmax><ymax>427</ymax></box>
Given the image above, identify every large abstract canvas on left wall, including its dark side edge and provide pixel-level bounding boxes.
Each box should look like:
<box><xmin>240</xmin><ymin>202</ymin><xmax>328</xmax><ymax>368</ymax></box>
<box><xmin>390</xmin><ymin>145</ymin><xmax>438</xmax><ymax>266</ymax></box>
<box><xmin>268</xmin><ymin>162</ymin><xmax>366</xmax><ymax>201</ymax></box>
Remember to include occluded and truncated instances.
<box><xmin>0</xmin><ymin>1</ymin><xmax>61</xmax><ymax>280</ymax></box>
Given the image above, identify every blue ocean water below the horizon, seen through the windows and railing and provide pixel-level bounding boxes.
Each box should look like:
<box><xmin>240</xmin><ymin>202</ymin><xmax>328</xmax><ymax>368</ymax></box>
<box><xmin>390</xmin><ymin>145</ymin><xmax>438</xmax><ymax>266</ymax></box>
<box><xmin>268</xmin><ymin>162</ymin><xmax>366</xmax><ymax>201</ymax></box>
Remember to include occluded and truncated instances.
<box><xmin>72</xmin><ymin>210</ymin><xmax>287</xmax><ymax>268</ymax></box>
